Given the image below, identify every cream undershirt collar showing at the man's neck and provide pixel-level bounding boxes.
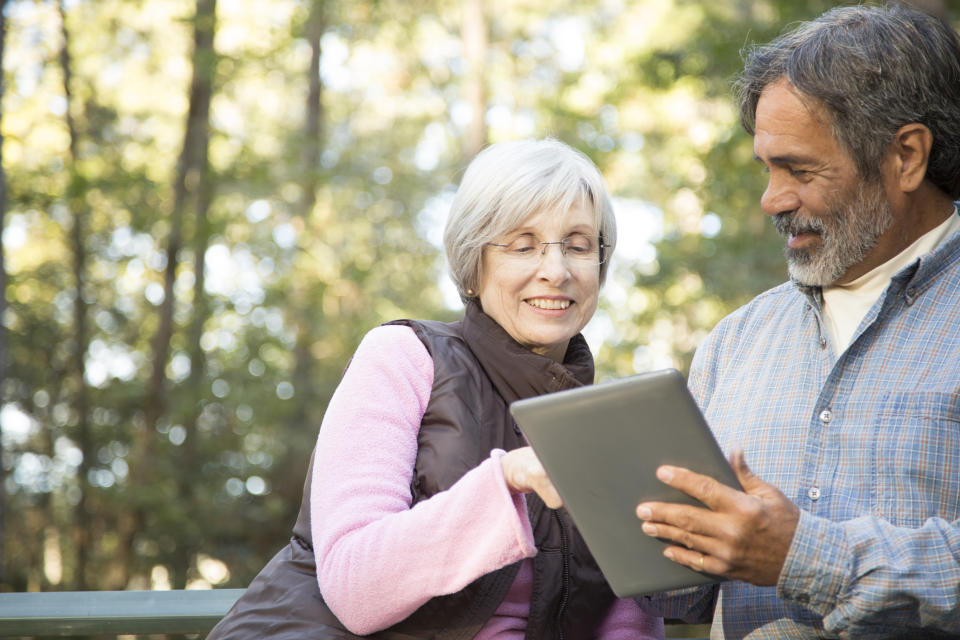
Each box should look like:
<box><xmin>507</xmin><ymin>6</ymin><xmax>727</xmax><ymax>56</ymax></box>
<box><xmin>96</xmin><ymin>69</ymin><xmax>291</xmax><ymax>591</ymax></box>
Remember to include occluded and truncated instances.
<box><xmin>823</xmin><ymin>206</ymin><xmax>960</xmax><ymax>356</ymax></box>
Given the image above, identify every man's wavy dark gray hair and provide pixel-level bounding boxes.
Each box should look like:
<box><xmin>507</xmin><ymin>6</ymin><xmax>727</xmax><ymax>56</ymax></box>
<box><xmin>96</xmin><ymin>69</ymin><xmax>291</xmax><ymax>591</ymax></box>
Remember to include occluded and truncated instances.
<box><xmin>736</xmin><ymin>5</ymin><xmax>960</xmax><ymax>199</ymax></box>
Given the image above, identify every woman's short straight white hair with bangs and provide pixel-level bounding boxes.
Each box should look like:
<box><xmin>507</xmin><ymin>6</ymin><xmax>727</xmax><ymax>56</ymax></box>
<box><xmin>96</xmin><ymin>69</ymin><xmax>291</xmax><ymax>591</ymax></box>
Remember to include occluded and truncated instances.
<box><xmin>443</xmin><ymin>138</ymin><xmax>617</xmax><ymax>301</ymax></box>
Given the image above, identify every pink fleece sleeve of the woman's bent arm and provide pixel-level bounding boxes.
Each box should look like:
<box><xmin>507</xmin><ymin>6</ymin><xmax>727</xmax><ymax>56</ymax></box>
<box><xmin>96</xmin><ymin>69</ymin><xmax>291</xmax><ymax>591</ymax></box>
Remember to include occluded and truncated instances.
<box><xmin>310</xmin><ymin>326</ymin><xmax>536</xmax><ymax>635</ymax></box>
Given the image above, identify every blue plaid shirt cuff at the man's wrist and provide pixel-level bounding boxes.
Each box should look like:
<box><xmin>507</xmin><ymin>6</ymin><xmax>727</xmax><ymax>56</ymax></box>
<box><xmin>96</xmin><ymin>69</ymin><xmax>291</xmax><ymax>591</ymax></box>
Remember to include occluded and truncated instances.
<box><xmin>777</xmin><ymin>510</ymin><xmax>850</xmax><ymax>616</ymax></box>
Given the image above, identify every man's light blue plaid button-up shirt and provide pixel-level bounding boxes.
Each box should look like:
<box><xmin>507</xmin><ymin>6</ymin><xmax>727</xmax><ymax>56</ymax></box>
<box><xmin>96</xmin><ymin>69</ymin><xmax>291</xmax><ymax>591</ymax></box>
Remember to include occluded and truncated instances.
<box><xmin>638</xmin><ymin>214</ymin><xmax>960</xmax><ymax>640</ymax></box>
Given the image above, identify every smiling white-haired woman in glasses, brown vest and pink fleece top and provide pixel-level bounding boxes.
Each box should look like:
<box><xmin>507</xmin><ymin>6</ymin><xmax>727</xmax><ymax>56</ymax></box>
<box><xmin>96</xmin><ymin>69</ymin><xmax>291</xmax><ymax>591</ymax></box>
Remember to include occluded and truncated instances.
<box><xmin>209</xmin><ymin>140</ymin><xmax>663</xmax><ymax>640</ymax></box>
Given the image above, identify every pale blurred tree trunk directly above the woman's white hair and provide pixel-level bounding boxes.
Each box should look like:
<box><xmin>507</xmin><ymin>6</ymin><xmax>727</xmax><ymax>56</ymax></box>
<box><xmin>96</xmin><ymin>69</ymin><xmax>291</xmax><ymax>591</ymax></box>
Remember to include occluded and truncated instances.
<box><xmin>461</xmin><ymin>0</ymin><xmax>488</xmax><ymax>162</ymax></box>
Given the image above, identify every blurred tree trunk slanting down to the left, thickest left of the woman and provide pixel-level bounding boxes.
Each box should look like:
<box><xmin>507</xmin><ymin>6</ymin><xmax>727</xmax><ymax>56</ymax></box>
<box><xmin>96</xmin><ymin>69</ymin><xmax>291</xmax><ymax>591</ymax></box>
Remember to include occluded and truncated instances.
<box><xmin>121</xmin><ymin>0</ymin><xmax>217</xmax><ymax>592</ymax></box>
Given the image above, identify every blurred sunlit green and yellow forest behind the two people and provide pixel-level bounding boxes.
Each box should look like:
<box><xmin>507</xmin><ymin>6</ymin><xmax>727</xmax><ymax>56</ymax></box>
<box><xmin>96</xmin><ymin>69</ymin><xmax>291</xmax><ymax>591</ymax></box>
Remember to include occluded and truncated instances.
<box><xmin>0</xmin><ymin>0</ymin><xmax>960</xmax><ymax>591</ymax></box>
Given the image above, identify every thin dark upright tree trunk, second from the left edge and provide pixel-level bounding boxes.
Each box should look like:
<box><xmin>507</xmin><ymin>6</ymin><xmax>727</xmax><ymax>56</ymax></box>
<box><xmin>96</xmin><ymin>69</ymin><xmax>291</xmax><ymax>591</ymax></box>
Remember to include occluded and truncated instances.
<box><xmin>60</xmin><ymin>0</ymin><xmax>93</xmax><ymax>590</ymax></box>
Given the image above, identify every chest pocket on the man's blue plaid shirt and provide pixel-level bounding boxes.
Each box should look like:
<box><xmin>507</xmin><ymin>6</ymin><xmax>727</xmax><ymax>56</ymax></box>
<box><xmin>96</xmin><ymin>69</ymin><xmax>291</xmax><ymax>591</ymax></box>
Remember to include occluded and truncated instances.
<box><xmin>874</xmin><ymin>391</ymin><xmax>960</xmax><ymax>527</ymax></box>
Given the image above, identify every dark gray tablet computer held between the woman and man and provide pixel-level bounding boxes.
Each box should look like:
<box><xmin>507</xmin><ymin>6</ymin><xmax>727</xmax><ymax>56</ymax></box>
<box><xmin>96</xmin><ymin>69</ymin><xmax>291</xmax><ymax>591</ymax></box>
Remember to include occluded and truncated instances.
<box><xmin>510</xmin><ymin>369</ymin><xmax>740</xmax><ymax>598</ymax></box>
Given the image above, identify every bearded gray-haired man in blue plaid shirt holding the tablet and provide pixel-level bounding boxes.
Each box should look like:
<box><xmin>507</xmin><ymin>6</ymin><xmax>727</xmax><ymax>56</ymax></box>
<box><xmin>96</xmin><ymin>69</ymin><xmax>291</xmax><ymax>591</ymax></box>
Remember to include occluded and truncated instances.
<box><xmin>637</xmin><ymin>6</ymin><xmax>960</xmax><ymax>639</ymax></box>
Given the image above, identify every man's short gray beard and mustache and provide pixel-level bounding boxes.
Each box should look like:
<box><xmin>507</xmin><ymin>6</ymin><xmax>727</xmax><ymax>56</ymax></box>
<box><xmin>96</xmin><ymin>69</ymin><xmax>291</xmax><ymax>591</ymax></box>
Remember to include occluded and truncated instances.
<box><xmin>773</xmin><ymin>181</ymin><xmax>893</xmax><ymax>287</ymax></box>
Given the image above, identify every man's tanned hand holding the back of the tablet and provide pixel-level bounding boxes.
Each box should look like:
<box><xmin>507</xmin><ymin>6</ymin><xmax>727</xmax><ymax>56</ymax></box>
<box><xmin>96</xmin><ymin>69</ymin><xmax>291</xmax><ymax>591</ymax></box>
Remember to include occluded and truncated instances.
<box><xmin>637</xmin><ymin>449</ymin><xmax>800</xmax><ymax>586</ymax></box>
